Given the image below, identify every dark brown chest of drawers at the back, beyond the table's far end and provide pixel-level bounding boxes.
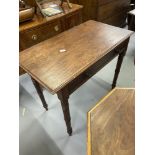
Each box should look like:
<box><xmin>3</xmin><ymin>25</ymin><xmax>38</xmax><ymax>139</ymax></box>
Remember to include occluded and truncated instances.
<box><xmin>70</xmin><ymin>0</ymin><xmax>130</xmax><ymax>27</ymax></box>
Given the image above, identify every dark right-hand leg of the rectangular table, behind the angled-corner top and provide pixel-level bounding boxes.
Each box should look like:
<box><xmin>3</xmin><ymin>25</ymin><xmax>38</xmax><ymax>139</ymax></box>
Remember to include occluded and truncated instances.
<box><xmin>112</xmin><ymin>47</ymin><xmax>127</xmax><ymax>89</ymax></box>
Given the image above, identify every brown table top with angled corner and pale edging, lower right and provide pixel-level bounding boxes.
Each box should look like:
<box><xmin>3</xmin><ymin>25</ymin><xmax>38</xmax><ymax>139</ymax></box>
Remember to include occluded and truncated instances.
<box><xmin>87</xmin><ymin>88</ymin><xmax>135</xmax><ymax>155</ymax></box>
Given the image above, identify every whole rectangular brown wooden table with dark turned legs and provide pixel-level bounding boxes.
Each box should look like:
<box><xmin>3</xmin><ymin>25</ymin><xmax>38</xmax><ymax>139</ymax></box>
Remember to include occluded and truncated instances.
<box><xmin>20</xmin><ymin>21</ymin><xmax>132</xmax><ymax>135</ymax></box>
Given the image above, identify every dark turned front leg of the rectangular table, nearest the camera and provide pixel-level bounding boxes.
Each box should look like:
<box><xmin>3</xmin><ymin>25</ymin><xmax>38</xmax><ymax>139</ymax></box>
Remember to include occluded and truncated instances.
<box><xmin>57</xmin><ymin>89</ymin><xmax>72</xmax><ymax>136</ymax></box>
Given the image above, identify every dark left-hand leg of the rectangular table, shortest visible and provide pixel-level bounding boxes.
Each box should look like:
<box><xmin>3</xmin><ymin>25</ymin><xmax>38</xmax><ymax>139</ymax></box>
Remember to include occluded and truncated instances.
<box><xmin>31</xmin><ymin>77</ymin><xmax>48</xmax><ymax>110</ymax></box>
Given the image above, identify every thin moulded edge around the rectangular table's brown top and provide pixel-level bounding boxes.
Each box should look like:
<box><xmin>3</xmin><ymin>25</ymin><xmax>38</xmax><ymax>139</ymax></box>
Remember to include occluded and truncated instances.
<box><xmin>20</xmin><ymin>20</ymin><xmax>134</xmax><ymax>95</ymax></box>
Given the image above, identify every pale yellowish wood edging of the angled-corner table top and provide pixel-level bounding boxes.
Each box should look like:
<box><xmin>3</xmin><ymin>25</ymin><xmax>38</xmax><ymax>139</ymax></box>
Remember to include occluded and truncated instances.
<box><xmin>87</xmin><ymin>87</ymin><xmax>135</xmax><ymax>155</ymax></box>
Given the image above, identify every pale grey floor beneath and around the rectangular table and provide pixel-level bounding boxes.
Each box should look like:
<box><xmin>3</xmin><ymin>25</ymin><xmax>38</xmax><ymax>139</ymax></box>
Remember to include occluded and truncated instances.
<box><xmin>19</xmin><ymin>35</ymin><xmax>135</xmax><ymax>155</ymax></box>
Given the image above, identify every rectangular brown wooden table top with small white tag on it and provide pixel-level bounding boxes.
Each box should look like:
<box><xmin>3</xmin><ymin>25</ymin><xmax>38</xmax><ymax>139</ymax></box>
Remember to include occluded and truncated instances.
<box><xmin>20</xmin><ymin>20</ymin><xmax>133</xmax><ymax>94</ymax></box>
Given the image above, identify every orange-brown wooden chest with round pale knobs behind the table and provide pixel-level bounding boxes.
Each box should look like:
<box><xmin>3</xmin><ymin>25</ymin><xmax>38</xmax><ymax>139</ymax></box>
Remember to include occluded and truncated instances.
<box><xmin>19</xmin><ymin>3</ymin><xmax>82</xmax><ymax>75</ymax></box>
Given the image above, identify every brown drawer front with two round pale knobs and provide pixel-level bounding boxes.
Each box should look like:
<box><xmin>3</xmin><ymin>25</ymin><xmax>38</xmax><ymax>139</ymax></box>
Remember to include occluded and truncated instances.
<box><xmin>19</xmin><ymin>21</ymin><xmax>62</xmax><ymax>50</ymax></box>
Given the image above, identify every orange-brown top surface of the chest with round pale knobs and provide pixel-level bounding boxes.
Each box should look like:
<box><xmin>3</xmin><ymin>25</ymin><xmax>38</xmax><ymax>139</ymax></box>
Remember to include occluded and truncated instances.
<box><xmin>19</xmin><ymin>2</ymin><xmax>83</xmax><ymax>32</ymax></box>
